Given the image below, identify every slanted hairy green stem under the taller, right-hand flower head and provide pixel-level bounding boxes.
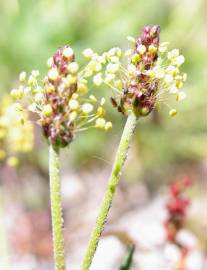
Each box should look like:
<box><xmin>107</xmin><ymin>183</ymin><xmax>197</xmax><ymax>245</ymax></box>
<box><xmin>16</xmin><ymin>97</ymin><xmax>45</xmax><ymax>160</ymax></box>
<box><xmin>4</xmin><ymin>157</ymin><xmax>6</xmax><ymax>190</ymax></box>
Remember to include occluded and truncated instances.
<box><xmin>82</xmin><ymin>113</ymin><xmax>137</xmax><ymax>270</ymax></box>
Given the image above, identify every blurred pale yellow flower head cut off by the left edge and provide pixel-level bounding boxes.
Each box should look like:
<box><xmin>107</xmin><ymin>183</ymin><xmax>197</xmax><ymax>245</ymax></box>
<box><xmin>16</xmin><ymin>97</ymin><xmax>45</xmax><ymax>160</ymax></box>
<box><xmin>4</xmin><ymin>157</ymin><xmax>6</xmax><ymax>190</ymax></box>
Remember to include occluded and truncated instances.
<box><xmin>0</xmin><ymin>96</ymin><xmax>33</xmax><ymax>166</ymax></box>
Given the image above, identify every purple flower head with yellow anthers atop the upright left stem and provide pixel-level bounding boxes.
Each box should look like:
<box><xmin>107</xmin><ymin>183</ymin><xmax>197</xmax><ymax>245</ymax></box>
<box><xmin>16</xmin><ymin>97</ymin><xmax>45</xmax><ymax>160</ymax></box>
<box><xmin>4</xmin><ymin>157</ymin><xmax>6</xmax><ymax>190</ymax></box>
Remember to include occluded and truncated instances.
<box><xmin>11</xmin><ymin>46</ymin><xmax>112</xmax><ymax>148</ymax></box>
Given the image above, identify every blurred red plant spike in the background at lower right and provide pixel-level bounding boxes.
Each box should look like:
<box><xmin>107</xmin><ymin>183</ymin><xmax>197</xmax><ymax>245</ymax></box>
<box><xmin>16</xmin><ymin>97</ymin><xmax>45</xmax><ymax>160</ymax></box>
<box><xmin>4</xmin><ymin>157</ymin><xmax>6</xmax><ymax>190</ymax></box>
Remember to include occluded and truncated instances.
<box><xmin>165</xmin><ymin>176</ymin><xmax>191</xmax><ymax>254</ymax></box>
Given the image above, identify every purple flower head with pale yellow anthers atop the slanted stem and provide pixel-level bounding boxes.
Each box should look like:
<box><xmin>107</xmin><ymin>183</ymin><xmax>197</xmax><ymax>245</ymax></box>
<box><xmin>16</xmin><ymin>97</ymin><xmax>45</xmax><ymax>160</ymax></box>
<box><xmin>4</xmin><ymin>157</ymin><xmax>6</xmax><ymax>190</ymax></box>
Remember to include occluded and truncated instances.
<box><xmin>85</xmin><ymin>26</ymin><xmax>187</xmax><ymax>117</ymax></box>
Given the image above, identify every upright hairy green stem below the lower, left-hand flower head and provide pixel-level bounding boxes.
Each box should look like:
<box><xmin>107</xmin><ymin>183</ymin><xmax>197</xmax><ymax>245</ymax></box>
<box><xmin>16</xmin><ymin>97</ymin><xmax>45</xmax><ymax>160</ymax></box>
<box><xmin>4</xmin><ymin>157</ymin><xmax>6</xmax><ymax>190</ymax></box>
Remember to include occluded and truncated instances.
<box><xmin>49</xmin><ymin>145</ymin><xmax>65</xmax><ymax>270</ymax></box>
